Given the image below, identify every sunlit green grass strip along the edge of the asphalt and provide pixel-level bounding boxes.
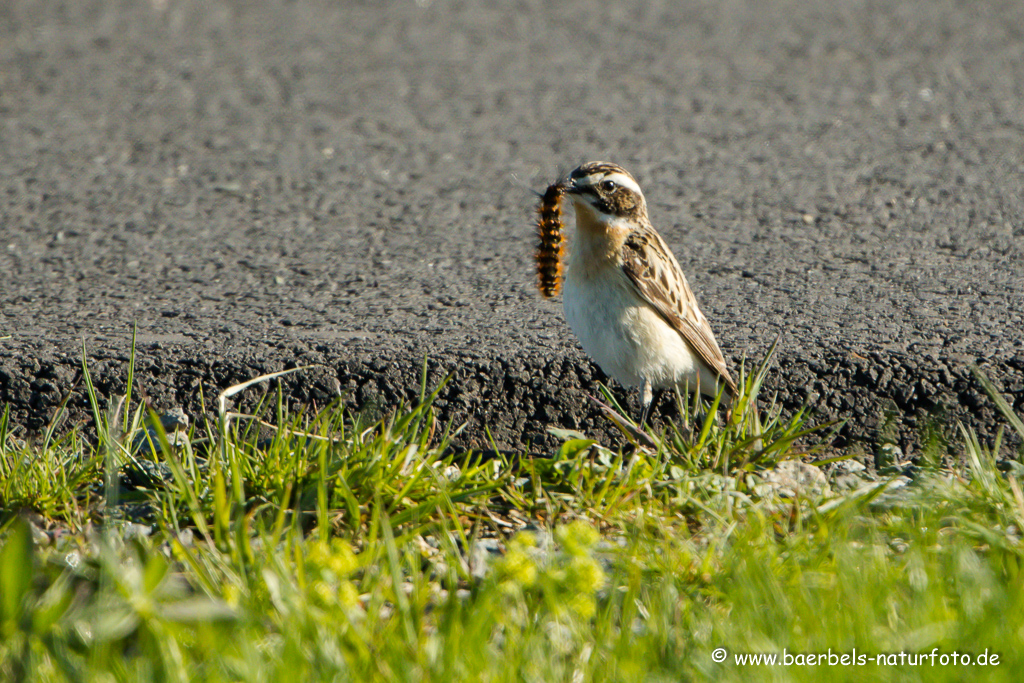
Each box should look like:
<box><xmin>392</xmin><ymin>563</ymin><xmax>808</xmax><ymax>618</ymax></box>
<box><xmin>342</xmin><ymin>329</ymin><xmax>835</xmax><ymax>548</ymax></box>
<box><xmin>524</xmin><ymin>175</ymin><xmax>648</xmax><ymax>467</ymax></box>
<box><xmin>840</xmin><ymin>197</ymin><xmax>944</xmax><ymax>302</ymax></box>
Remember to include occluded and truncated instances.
<box><xmin>0</xmin><ymin>348</ymin><xmax>1024</xmax><ymax>681</ymax></box>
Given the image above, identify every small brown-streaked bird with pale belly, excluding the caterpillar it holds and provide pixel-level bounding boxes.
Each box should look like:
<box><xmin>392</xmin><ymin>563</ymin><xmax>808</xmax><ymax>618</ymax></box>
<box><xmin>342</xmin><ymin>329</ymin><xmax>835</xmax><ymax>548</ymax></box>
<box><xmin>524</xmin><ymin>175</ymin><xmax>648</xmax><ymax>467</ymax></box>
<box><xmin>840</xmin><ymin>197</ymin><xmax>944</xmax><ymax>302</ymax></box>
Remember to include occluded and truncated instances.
<box><xmin>560</xmin><ymin>162</ymin><xmax>738</xmax><ymax>428</ymax></box>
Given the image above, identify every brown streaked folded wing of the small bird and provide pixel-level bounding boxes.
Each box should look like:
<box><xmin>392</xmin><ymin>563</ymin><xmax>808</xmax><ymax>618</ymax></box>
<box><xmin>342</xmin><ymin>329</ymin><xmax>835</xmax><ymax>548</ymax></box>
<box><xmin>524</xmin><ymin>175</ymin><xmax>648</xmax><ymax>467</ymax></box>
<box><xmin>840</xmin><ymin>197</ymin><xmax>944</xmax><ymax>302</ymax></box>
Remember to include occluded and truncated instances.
<box><xmin>622</xmin><ymin>229</ymin><xmax>736</xmax><ymax>395</ymax></box>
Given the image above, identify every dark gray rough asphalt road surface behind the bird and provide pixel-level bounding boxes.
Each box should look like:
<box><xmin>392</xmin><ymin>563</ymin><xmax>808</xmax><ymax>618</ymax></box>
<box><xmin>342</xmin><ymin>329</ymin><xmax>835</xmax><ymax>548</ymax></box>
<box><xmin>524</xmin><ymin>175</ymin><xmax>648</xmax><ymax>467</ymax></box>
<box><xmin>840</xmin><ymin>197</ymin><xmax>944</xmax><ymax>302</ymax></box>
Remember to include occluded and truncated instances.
<box><xmin>0</xmin><ymin>0</ymin><xmax>1024</xmax><ymax>456</ymax></box>
